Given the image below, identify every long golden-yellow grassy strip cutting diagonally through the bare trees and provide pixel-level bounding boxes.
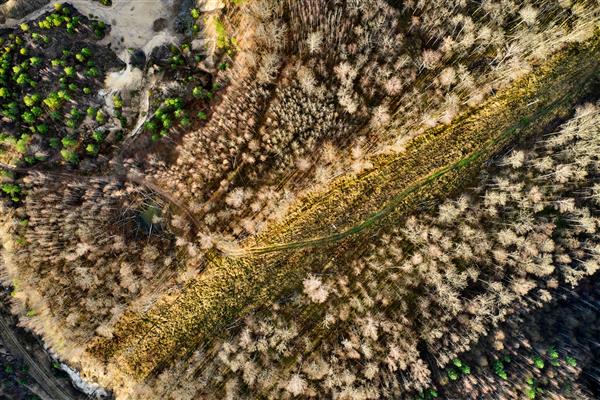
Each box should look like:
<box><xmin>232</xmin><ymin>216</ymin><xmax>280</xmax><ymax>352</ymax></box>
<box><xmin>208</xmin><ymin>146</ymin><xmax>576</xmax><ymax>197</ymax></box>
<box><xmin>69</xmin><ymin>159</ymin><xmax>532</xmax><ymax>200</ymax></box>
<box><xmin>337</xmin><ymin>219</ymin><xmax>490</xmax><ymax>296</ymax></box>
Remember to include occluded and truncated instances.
<box><xmin>90</xmin><ymin>34</ymin><xmax>600</xmax><ymax>380</ymax></box>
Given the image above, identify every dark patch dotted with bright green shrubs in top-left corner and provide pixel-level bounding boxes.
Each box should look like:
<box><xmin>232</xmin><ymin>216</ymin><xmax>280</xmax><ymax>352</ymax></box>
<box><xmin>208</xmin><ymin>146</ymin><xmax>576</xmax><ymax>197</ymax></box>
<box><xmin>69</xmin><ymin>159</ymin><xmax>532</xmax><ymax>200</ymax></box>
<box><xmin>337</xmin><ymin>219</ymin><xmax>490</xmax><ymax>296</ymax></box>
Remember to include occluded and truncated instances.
<box><xmin>0</xmin><ymin>5</ymin><xmax>124</xmax><ymax>176</ymax></box>
